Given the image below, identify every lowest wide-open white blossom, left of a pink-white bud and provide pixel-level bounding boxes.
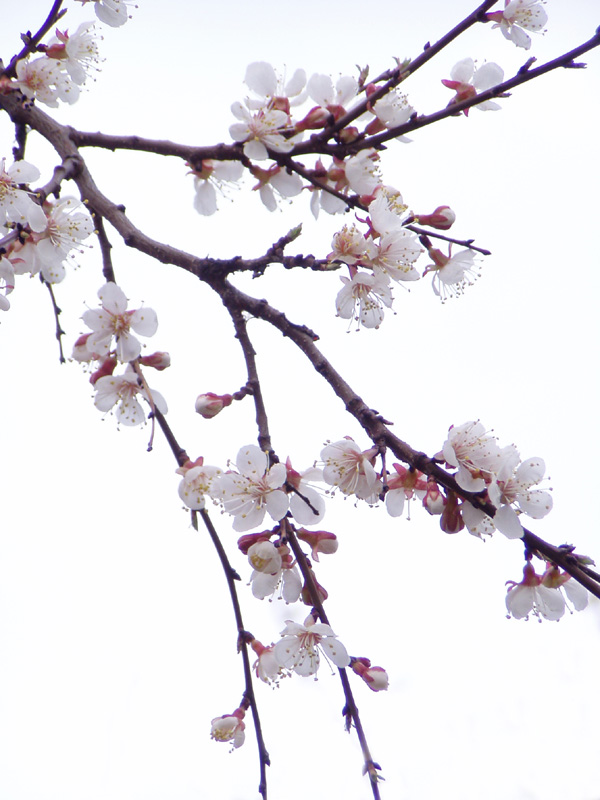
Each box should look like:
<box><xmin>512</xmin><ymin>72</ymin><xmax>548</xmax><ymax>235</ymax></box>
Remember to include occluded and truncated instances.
<box><xmin>273</xmin><ymin>615</ymin><xmax>350</xmax><ymax>677</ymax></box>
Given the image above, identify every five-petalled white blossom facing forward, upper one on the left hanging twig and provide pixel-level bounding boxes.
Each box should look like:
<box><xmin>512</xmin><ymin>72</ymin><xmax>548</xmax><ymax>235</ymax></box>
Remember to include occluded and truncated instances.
<box><xmin>82</xmin><ymin>283</ymin><xmax>158</xmax><ymax>362</ymax></box>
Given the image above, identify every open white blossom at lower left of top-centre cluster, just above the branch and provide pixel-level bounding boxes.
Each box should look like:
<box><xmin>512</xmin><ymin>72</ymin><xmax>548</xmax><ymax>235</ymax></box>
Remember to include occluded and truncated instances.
<box><xmin>229</xmin><ymin>102</ymin><xmax>294</xmax><ymax>161</ymax></box>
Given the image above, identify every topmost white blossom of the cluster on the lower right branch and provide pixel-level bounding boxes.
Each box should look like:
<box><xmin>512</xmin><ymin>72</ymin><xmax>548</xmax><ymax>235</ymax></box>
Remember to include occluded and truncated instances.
<box><xmin>441</xmin><ymin>421</ymin><xmax>502</xmax><ymax>492</ymax></box>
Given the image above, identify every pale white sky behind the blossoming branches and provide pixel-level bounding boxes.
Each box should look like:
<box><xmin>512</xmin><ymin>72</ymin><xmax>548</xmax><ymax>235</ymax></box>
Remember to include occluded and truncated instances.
<box><xmin>0</xmin><ymin>0</ymin><xmax>600</xmax><ymax>800</ymax></box>
